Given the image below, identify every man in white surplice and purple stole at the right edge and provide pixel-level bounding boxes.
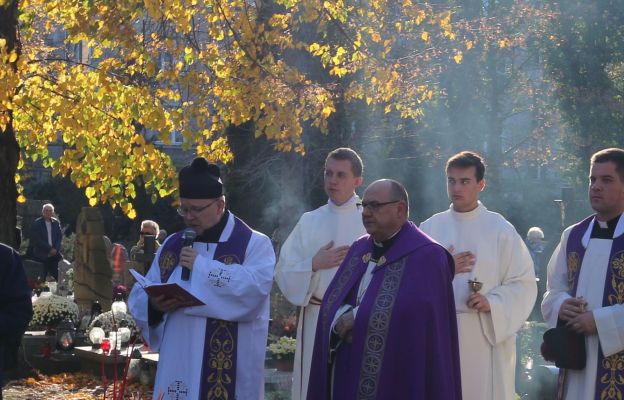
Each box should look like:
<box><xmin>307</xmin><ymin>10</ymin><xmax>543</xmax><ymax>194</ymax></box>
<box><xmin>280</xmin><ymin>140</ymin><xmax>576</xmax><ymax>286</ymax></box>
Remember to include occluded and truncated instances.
<box><xmin>542</xmin><ymin>148</ymin><xmax>624</xmax><ymax>400</ymax></box>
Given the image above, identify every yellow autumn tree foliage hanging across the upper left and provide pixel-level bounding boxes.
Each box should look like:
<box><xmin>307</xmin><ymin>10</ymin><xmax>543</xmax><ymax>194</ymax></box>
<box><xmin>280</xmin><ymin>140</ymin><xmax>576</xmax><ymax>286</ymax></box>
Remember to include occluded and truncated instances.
<box><xmin>0</xmin><ymin>0</ymin><xmax>466</xmax><ymax>241</ymax></box>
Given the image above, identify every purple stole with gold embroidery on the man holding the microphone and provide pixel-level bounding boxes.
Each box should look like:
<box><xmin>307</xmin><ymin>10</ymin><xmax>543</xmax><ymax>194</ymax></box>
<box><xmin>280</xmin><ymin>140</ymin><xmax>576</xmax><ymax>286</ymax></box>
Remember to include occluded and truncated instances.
<box><xmin>158</xmin><ymin>217</ymin><xmax>253</xmax><ymax>400</ymax></box>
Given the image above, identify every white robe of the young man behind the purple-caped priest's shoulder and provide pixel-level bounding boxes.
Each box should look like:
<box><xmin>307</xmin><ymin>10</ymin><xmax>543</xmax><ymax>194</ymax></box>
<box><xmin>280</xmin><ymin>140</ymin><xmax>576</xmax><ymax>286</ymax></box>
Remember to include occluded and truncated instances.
<box><xmin>275</xmin><ymin>195</ymin><xmax>366</xmax><ymax>400</ymax></box>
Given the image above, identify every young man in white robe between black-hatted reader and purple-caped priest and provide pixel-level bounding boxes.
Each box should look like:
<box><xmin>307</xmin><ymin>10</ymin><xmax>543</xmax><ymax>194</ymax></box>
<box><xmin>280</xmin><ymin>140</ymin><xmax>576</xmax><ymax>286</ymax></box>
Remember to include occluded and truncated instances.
<box><xmin>275</xmin><ymin>148</ymin><xmax>366</xmax><ymax>400</ymax></box>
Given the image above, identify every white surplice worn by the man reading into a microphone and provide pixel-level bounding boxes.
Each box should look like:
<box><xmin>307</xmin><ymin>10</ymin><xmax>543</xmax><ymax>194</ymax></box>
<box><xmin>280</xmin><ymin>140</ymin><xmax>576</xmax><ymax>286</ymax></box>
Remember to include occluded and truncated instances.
<box><xmin>128</xmin><ymin>213</ymin><xmax>275</xmax><ymax>400</ymax></box>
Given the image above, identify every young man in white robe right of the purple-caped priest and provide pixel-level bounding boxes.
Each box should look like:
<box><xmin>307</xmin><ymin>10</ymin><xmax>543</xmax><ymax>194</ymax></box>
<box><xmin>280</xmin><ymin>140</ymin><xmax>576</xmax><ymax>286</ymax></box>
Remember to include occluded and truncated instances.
<box><xmin>420</xmin><ymin>151</ymin><xmax>537</xmax><ymax>400</ymax></box>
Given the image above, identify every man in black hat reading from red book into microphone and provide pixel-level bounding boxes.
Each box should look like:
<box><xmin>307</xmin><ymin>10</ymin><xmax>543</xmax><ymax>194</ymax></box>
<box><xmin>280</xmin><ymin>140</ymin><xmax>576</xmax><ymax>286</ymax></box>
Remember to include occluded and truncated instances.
<box><xmin>128</xmin><ymin>158</ymin><xmax>275</xmax><ymax>400</ymax></box>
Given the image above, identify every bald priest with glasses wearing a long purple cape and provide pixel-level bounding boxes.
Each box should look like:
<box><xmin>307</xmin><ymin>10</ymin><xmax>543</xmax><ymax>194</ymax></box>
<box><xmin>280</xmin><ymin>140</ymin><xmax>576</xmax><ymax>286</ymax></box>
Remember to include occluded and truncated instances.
<box><xmin>308</xmin><ymin>179</ymin><xmax>461</xmax><ymax>400</ymax></box>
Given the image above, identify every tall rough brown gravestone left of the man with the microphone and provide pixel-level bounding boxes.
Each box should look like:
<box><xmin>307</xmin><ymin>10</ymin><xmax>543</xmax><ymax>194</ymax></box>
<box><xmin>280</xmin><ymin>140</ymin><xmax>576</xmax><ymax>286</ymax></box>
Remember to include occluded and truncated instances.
<box><xmin>73</xmin><ymin>207</ymin><xmax>113</xmax><ymax>315</ymax></box>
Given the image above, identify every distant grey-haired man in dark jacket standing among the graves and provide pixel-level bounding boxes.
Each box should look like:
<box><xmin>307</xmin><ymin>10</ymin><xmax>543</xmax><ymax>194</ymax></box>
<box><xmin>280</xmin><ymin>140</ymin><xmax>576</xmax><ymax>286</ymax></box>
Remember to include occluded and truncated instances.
<box><xmin>30</xmin><ymin>203</ymin><xmax>63</xmax><ymax>281</ymax></box>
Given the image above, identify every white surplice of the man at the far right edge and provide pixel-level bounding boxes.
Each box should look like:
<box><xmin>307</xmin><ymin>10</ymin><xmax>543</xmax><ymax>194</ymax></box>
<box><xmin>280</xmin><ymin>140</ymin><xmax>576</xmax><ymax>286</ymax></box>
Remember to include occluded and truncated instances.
<box><xmin>542</xmin><ymin>217</ymin><xmax>624</xmax><ymax>400</ymax></box>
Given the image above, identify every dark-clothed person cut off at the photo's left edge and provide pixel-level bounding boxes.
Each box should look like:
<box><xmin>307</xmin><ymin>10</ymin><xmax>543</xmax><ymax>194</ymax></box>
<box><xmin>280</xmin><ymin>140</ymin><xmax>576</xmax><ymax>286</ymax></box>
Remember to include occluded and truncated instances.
<box><xmin>0</xmin><ymin>243</ymin><xmax>33</xmax><ymax>400</ymax></box>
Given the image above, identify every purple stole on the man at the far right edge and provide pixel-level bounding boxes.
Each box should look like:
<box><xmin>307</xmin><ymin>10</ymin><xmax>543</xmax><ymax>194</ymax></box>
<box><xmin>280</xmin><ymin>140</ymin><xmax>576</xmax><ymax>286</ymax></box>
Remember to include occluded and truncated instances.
<box><xmin>557</xmin><ymin>216</ymin><xmax>624</xmax><ymax>399</ymax></box>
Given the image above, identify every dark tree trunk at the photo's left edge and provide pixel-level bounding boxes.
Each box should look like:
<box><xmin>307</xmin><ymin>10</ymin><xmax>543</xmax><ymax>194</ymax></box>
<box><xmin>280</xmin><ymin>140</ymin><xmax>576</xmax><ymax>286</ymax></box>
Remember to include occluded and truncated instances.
<box><xmin>0</xmin><ymin>0</ymin><xmax>20</xmax><ymax>246</ymax></box>
